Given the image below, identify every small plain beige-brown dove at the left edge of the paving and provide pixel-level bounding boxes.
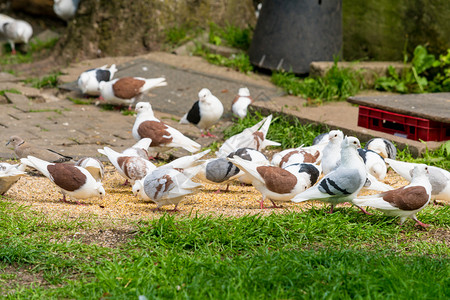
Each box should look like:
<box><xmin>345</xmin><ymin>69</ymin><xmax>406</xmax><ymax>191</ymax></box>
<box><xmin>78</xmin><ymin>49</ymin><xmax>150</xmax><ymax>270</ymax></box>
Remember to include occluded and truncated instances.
<box><xmin>6</xmin><ymin>135</ymin><xmax>72</xmax><ymax>163</ymax></box>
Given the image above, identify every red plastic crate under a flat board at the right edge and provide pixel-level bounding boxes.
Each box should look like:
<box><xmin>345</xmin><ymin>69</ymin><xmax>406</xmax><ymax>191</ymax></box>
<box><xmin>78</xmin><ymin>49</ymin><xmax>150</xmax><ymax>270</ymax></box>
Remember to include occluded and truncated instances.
<box><xmin>358</xmin><ymin>106</ymin><xmax>450</xmax><ymax>141</ymax></box>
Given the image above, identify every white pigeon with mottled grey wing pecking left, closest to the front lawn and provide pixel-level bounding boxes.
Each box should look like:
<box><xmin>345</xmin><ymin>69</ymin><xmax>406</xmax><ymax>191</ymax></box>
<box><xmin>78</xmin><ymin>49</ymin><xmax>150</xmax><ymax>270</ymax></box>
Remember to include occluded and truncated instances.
<box><xmin>132</xmin><ymin>166</ymin><xmax>201</xmax><ymax>211</ymax></box>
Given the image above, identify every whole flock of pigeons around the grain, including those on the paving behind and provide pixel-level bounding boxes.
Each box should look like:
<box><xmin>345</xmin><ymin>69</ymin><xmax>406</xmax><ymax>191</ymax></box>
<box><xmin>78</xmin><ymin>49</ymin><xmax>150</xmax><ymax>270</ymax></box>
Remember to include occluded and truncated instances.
<box><xmin>0</xmin><ymin>65</ymin><xmax>450</xmax><ymax>227</ymax></box>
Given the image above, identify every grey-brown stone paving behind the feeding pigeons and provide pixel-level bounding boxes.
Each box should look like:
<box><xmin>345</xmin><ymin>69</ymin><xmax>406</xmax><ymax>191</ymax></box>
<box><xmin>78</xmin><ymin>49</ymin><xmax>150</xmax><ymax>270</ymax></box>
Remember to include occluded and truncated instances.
<box><xmin>0</xmin><ymin>52</ymin><xmax>440</xmax><ymax>159</ymax></box>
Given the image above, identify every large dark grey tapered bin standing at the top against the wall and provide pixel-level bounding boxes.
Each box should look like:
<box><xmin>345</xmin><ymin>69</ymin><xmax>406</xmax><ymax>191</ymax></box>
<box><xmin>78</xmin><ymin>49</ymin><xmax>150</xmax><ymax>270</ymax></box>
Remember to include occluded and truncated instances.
<box><xmin>249</xmin><ymin>0</ymin><xmax>342</xmax><ymax>74</ymax></box>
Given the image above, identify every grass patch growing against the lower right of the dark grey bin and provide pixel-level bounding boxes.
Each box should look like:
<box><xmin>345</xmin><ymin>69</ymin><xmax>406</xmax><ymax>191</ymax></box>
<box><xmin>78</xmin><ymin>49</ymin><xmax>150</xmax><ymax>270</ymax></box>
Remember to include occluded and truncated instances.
<box><xmin>271</xmin><ymin>59</ymin><xmax>363</xmax><ymax>104</ymax></box>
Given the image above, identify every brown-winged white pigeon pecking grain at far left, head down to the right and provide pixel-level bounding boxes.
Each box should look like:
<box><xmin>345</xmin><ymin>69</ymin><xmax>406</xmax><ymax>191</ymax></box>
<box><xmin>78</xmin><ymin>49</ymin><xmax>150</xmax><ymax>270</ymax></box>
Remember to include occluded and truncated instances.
<box><xmin>20</xmin><ymin>156</ymin><xmax>105</xmax><ymax>202</ymax></box>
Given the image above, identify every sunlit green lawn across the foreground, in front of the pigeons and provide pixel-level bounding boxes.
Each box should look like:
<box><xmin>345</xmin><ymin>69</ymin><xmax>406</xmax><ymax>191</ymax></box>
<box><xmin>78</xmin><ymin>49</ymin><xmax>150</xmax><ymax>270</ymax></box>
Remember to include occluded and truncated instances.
<box><xmin>0</xmin><ymin>201</ymin><xmax>450</xmax><ymax>299</ymax></box>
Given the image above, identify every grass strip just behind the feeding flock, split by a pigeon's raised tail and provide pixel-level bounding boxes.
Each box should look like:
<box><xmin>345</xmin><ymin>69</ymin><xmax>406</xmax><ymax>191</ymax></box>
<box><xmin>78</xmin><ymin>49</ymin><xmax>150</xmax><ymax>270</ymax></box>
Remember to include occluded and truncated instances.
<box><xmin>224</xmin><ymin>111</ymin><xmax>329</xmax><ymax>149</ymax></box>
